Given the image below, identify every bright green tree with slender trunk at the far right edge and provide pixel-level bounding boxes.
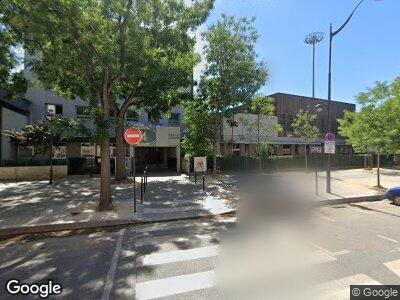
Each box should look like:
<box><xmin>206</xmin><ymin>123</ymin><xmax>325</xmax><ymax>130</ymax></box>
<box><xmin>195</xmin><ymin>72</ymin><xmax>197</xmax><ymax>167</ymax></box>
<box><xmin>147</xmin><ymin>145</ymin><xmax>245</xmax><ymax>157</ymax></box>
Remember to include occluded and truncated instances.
<box><xmin>339</xmin><ymin>77</ymin><xmax>400</xmax><ymax>187</ymax></box>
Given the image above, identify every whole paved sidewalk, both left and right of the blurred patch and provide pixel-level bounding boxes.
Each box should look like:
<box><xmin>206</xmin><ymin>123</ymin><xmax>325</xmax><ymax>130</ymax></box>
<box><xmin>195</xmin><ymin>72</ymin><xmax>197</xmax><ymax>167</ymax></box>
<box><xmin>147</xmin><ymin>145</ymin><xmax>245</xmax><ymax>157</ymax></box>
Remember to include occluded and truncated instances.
<box><xmin>0</xmin><ymin>169</ymin><xmax>394</xmax><ymax>235</ymax></box>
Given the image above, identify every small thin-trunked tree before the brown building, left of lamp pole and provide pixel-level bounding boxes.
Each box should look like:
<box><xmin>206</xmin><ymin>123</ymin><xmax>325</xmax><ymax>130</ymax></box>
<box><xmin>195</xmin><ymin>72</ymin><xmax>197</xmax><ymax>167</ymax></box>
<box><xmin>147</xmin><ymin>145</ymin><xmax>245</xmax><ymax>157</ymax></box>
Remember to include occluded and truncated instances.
<box><xmin>292</xmin><ymin>109</ymin><xmax>321</xmax><ymax>171</ymax></box>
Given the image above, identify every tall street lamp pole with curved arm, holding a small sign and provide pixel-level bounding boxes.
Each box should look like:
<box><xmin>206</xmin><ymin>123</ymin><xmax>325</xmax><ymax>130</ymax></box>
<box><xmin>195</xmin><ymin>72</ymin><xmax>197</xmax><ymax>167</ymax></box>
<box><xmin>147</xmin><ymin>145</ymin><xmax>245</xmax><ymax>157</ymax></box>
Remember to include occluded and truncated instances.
<box><xmin>326</xmin><ymin>0</ymin><xmax>381</xmax><ymax>193</ymax></box>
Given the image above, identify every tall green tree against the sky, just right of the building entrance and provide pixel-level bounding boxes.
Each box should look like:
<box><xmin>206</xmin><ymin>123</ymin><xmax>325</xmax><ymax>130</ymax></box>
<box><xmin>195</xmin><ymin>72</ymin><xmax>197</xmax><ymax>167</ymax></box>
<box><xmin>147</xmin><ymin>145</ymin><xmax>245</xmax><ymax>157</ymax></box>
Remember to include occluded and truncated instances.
<box><xmin>198</xmin><ymin>15</ymin><xmax>267</xmax><ymax>175</ymax></box>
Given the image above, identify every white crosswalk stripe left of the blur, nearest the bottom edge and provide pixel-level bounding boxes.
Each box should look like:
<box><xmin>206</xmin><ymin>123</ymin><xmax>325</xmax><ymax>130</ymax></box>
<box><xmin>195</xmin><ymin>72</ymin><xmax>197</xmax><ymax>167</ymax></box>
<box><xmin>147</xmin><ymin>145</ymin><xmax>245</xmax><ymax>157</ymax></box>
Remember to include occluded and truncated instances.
<box><xmin>136</xmin><ymin>271</ymin><xmax>215</xmax><ymax>300</ymax></box>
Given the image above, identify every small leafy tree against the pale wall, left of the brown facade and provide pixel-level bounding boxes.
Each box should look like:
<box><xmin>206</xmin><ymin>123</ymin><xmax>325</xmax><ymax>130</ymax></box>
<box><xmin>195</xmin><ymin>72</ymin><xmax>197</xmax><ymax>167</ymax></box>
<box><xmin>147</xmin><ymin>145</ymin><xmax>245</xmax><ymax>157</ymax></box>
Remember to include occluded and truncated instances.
<box><xmin>241</xmin><ymin>94</ymin><xmax>282</xmax><ymax>170</ymax></box>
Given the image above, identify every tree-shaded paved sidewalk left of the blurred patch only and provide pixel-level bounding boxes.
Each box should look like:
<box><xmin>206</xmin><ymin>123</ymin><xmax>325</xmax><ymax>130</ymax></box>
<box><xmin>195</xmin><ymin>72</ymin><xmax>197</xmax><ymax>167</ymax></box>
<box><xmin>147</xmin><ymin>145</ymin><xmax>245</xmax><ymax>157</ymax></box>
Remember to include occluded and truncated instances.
<box><xmin>0</xmin><ymin>174</ymin><xmax>238</xmax><ymax>235</ymax></box>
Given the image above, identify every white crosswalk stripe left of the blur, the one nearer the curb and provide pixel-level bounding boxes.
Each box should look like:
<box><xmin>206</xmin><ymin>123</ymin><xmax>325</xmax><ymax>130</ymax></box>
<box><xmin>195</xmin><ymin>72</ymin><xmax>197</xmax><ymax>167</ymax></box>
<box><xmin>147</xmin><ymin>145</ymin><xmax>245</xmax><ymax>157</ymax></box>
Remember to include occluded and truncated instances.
<box><xmin>142</xmin><ymin>246</ymin><xmax>218</xmax><ymax>266</ymax></box>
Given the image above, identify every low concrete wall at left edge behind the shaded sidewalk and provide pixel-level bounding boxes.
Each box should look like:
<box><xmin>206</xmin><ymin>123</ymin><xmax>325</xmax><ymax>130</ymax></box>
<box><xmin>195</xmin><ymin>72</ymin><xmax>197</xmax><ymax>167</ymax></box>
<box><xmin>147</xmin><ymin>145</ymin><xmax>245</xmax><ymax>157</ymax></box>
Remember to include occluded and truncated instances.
<box><xmin>0</xmin><ymin>166</ymin><xmax>68</xmax><ymax>180</ymax></box>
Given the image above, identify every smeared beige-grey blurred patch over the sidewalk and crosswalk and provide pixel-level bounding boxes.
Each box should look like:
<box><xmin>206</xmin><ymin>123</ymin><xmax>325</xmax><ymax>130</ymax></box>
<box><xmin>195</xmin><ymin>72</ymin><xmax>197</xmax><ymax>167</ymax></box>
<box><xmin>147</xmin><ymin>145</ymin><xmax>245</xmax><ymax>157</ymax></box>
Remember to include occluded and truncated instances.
<box><xmin>216</xmin><ymin>174</ymin><xmax>320</xmax><ymax>299</ymax></box>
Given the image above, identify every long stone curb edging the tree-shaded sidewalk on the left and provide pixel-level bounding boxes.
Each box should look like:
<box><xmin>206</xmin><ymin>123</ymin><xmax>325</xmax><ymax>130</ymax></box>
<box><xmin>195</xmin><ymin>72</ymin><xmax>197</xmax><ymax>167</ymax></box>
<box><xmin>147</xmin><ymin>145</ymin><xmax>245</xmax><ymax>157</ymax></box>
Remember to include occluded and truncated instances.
<box><xmin>0</xmin><ymin>209</ymin><xmax>236</xmax><ymax>238</ymax></box>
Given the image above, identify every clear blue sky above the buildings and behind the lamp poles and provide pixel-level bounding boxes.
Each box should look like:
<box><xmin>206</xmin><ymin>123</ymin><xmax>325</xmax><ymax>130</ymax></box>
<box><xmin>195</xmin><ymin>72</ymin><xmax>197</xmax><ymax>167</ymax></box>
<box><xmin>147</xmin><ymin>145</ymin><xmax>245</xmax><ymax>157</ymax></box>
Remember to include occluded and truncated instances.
<box><xmin>196</xmin><ymin>0</ymin><xmax>400</xmax><ymax>103</ymax></box>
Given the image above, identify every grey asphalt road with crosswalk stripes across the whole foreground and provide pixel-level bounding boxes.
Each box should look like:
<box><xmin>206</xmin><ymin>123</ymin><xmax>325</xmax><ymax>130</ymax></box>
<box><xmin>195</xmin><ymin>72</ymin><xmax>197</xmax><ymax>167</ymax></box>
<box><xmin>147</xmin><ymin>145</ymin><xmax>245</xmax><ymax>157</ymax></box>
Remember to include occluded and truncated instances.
<box><xmin>0</xmin><ymin>201</ymin><xmax>400</xmax><ymax>299</ymax></box>
